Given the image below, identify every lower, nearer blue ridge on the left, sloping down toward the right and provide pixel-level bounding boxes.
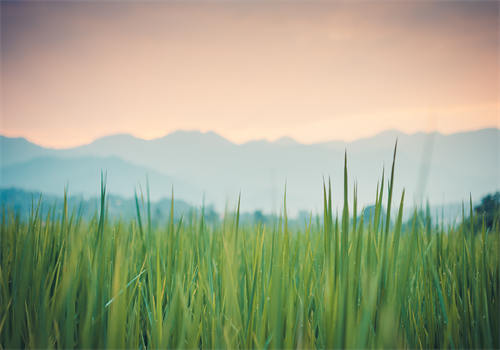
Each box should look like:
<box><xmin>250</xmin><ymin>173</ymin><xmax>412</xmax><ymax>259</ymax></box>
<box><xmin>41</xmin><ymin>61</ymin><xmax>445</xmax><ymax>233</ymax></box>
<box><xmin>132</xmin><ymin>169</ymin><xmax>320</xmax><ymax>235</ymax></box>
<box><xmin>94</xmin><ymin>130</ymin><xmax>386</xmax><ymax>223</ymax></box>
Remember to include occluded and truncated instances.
<box><xmin>0</xmin><ymin>156</ymin><xmax>201</xmax><ymax>201</ymax></box>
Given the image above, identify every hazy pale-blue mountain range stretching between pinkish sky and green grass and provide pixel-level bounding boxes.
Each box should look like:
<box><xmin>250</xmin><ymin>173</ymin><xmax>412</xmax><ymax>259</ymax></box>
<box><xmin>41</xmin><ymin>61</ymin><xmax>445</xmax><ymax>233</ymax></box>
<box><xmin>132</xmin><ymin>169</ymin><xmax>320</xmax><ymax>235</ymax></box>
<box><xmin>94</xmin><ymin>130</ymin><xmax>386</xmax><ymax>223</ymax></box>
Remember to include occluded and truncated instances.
<box><xmin>0</xmin><ymin>128</ymin><xmax>500</xmax><ymax>214</ymax></box>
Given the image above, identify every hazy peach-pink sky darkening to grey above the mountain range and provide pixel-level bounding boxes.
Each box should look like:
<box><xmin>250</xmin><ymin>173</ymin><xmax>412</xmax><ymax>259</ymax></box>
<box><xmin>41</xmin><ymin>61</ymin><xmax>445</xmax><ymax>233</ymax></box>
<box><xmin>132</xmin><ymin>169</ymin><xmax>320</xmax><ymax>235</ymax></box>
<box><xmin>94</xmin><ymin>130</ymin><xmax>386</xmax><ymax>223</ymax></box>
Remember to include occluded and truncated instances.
<box><xmin>1</xmin><ymin>0</ymin><xmax>500</xmax><ymax>147</ymax></box>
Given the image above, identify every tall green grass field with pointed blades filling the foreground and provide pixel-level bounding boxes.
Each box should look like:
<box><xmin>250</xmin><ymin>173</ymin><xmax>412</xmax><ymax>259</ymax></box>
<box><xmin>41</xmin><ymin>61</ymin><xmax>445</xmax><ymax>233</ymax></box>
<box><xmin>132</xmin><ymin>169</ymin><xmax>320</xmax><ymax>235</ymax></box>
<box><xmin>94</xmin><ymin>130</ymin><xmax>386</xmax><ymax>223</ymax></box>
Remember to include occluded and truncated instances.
<box><xmin>0</xmin><ymin>148</ymin><xmax>500</xmax><ymax>349</ymax></box>
